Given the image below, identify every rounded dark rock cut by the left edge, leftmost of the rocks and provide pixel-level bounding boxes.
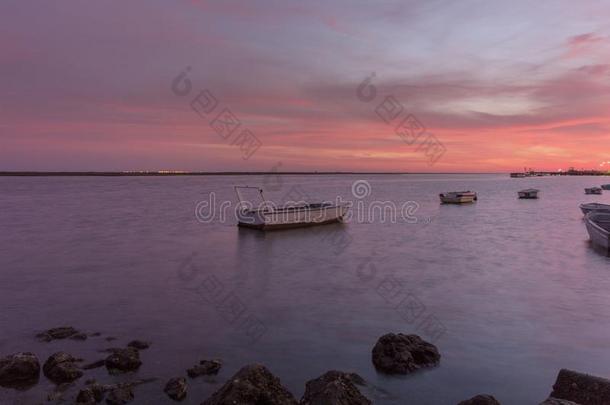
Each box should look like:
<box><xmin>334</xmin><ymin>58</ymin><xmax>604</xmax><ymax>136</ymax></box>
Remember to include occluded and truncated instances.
<box><xmin>0</xmin><ymin>352</ymin><xmax>40</xmax><ymax>388</ymax></box>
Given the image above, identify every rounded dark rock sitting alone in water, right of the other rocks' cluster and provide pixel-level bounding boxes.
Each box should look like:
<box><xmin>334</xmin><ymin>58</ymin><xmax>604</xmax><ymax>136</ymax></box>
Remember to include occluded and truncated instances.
<box><xmin>373</xmin><ymin>333</ymin><xmax>441</xmax><ymax>374</ymax></box>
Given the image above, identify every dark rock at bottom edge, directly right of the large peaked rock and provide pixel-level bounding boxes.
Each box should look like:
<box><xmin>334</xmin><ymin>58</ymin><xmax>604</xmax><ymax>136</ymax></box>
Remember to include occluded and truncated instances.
<box><xmin>300</xmin><ymin>371</ymin><xmax>371</xmax><ymax>405</ymax></box>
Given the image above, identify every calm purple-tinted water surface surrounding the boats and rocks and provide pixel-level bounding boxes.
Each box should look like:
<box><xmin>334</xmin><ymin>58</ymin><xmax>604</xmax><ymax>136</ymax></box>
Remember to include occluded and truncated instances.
<box><xmin>0</xmin><ymin>175</ymin><xmax>610</xmax><ymax>404</ymax></box>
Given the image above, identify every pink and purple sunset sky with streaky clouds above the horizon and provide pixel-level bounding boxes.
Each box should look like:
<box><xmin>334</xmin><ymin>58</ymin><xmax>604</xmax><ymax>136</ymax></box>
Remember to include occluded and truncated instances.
<box><xmin>0</xmin><ymin>0</ymin><xmax>610</xmax><ymax>172</ymax></box>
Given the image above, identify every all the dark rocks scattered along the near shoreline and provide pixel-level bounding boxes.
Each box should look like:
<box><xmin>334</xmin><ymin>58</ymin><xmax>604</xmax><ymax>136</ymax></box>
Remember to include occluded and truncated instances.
<box><xmin>0</xmin><ymin>326</ymin><xmax>610</xmax><ymax>405</ymax></box>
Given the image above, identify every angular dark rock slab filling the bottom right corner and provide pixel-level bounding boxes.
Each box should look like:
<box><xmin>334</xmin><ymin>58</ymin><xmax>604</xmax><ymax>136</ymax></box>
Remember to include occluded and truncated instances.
<box><xmin>551</xmin><ymin>369</ymin><xmax>610</xmax><ymax>405</ymax></box>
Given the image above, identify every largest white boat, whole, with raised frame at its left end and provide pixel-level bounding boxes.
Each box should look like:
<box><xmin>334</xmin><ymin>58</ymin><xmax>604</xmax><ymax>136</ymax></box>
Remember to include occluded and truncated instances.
<box><xmin>235</xmin><ymin>186</ymin><xmax>349</xmax><ymax>231</ymax></box>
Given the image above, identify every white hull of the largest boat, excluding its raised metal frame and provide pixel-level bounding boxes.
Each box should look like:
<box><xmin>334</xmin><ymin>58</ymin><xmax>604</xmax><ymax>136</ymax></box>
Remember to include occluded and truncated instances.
<box><xmin>237</xmin><ymin>205</ymin><xmax>349</xmax><ymax>231</ymax></box>
